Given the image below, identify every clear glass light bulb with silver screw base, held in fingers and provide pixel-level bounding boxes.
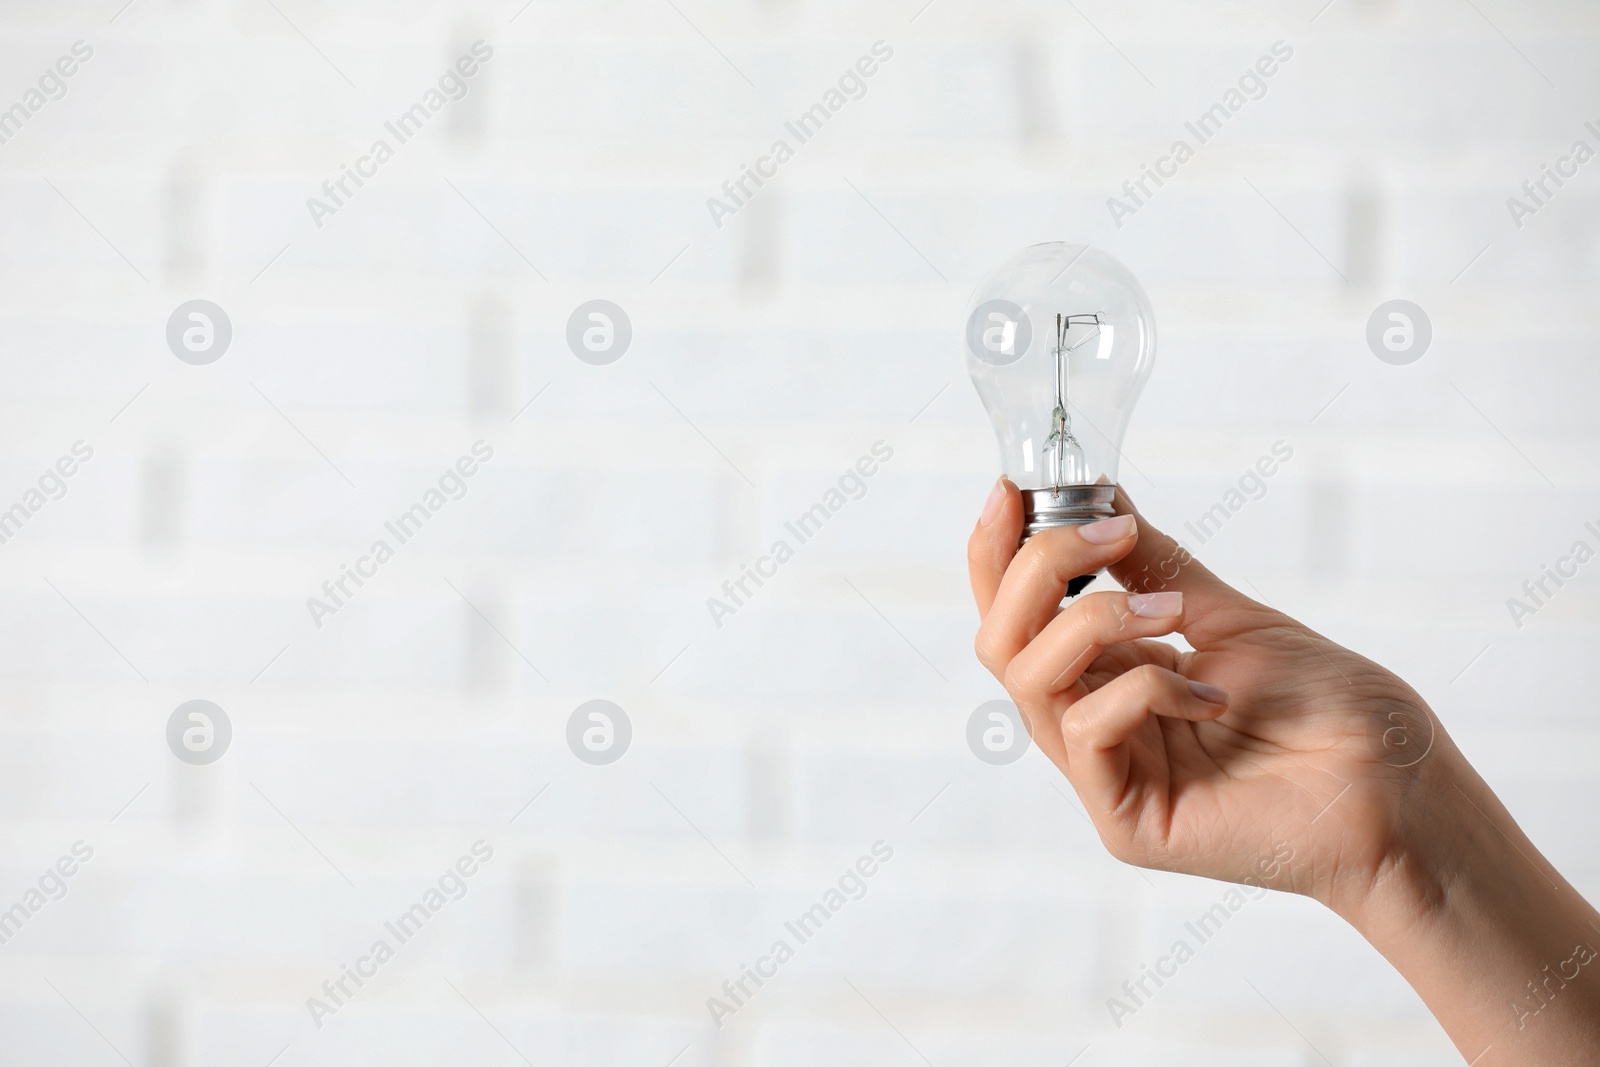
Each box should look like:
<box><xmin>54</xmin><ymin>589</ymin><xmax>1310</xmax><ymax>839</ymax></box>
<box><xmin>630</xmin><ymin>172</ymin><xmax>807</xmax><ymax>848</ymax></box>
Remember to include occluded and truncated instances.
<box><xmin>965</xmin><ymin>242</ymin><xmax>1155</xmax><ymax>593</ymax></box>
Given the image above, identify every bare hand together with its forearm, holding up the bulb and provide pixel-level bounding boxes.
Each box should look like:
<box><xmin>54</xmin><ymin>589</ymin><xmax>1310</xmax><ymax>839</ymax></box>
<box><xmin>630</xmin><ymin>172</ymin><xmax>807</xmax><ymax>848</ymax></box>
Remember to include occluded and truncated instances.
<box><xmin>968</xmin><ymin>478</ymin><xmax>1600</xmax><ymax>1067</ymax></box>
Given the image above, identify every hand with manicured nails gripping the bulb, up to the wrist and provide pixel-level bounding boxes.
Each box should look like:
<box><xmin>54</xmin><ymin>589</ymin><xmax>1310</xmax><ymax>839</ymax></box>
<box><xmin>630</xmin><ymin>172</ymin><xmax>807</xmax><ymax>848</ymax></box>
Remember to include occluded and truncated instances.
<box><xmin>968</xmin><ymin>482</ymin><xmax>1451</xmax><ymax>904</ymax></box>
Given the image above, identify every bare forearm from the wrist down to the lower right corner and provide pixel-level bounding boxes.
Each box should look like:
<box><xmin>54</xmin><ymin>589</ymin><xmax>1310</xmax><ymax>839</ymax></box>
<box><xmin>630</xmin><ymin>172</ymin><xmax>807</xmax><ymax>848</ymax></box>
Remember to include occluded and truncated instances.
<box><xmin>1336</xmin><ymin>750</ymin><xmax>1600</xmax><ymax>1067</ymax></box>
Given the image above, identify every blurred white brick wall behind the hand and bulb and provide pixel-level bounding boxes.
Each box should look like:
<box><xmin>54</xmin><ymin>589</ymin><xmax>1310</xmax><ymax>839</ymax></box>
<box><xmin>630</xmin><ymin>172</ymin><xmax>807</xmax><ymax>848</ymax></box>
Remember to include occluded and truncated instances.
<box><xmin>0</xmin><ymin>0</ymin><xmax>1600</xmax><ymax>1067</ymax></box>
